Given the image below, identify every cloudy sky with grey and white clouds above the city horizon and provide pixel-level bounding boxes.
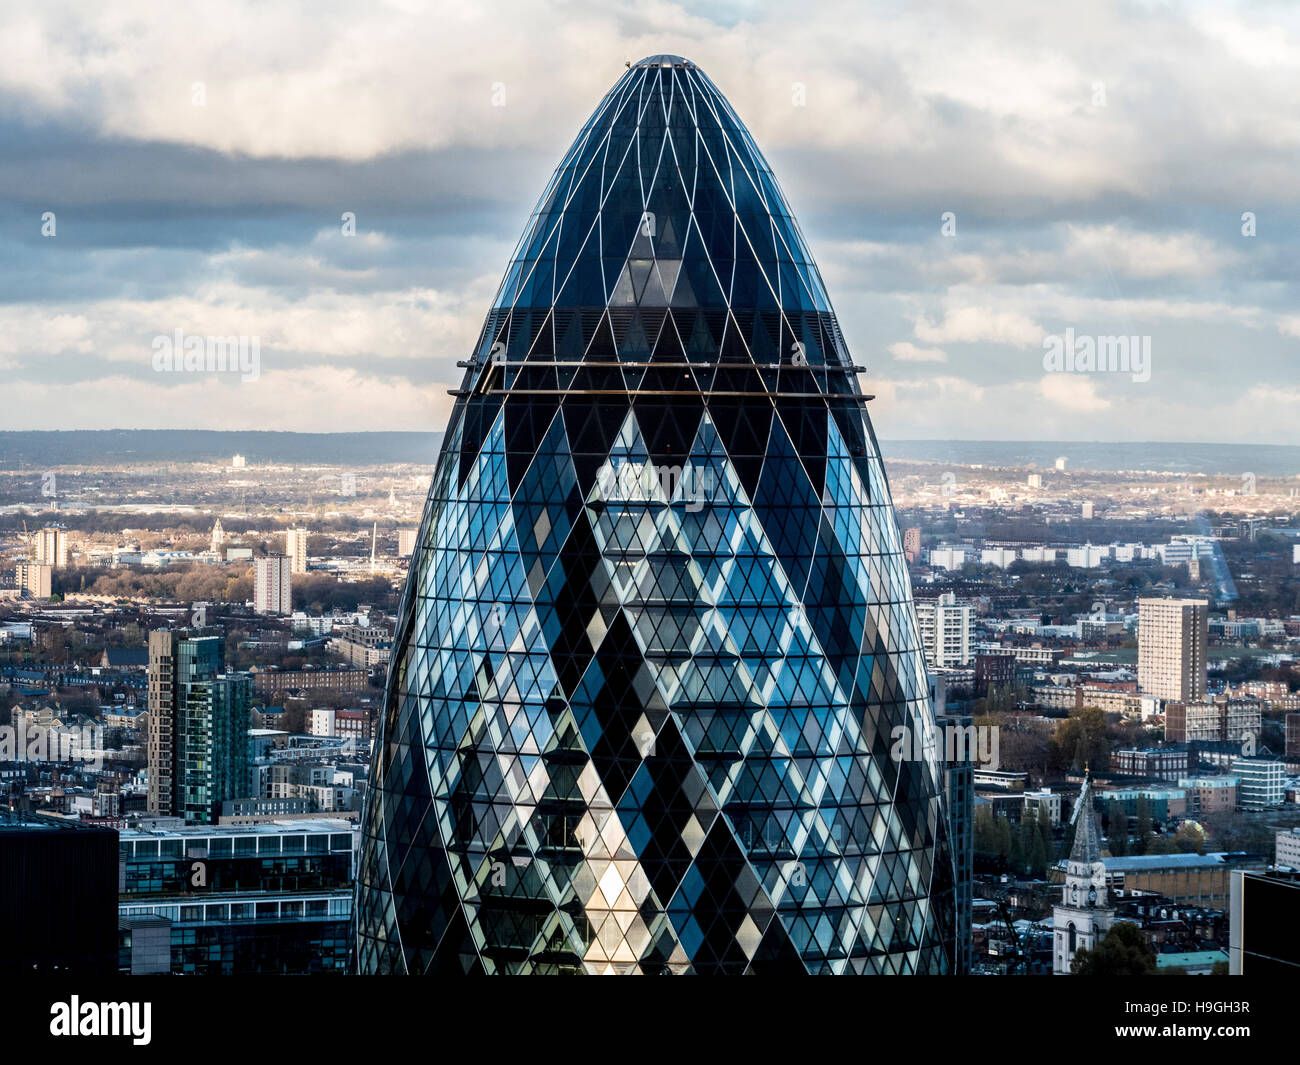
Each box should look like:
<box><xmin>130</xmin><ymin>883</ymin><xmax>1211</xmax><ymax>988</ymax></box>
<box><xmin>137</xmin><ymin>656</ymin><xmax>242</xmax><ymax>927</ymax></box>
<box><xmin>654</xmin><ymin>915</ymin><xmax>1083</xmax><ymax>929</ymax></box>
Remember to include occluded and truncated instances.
<box><xmin>0</xmin><ymin>0</ymin><xmax>1300</xmax><ymax>443</ymax></box>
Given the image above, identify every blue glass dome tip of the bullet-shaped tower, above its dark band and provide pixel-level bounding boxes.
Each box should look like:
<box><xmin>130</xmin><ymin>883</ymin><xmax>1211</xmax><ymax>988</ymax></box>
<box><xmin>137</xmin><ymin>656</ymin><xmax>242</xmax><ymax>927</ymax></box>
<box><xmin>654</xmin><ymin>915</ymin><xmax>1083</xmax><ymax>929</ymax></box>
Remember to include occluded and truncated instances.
<box><xmin>494</xmin><ymin>56</ymin><xmax>833</xmax><ymax>322</ymax></box>
